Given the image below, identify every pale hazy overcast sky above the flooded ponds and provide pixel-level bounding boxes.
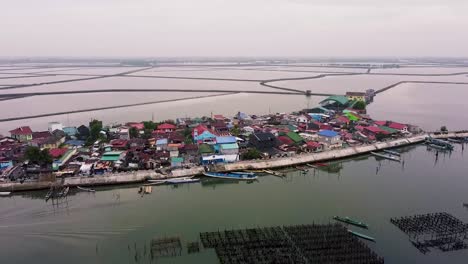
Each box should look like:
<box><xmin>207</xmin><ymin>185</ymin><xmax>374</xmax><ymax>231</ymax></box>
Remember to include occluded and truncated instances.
<box><xmin>0</xmin><ymin>0</ymin><xmax>468</xmax><ymax>57</ymax></box>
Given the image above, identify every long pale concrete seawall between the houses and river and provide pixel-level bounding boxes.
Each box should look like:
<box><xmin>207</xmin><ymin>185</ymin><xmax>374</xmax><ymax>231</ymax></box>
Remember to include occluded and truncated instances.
<box><xmin>0</xmin><ymin>131</ymin><xmax>468</xmax><ymax>192</ymax></box>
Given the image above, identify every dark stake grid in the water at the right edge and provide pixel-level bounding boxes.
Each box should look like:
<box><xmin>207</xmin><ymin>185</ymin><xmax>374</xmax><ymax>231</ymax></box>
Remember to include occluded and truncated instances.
<box><xmin>390</xmin><ymin>213</ymin><xmax>468</xmax><ymax>254</ymax></box>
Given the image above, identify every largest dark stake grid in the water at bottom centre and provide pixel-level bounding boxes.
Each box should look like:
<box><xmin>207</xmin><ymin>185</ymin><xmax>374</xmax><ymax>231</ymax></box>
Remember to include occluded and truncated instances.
<box><xmin>200</xmin><ymin>223</ymin><xmax>384</xmax><ymax>264</ymax></box>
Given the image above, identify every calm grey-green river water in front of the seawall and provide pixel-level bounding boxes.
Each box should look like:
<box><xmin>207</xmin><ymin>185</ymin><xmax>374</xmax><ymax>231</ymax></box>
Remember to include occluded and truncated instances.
<box><xmin>0</xmin><ymin>146</ymin><xmax>468</xmax><ymax>264</ymax></box>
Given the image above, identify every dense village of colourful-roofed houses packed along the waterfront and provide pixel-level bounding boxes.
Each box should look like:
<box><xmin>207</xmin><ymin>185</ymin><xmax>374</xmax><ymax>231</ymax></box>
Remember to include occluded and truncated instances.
<box><xmin>0</xmin><ymin>93</ymin><xmax>420</xmax><ymax>183</ymax></box>
